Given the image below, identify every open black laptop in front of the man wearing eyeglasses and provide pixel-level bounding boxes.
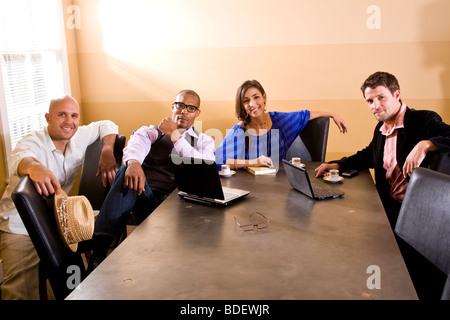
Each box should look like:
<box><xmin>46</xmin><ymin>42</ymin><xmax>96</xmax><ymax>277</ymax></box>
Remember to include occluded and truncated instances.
<box><xmin>172</xmin><ymin>155</ymin><xmax>250</xmax><ymax>206</ymax></box>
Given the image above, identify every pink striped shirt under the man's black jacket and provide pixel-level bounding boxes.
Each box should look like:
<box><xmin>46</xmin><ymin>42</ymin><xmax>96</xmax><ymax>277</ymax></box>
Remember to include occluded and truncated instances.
<box><xmin>380</xmin><ymin>104</ymin><xmax>408</xmax><ymax>202</ymax></box>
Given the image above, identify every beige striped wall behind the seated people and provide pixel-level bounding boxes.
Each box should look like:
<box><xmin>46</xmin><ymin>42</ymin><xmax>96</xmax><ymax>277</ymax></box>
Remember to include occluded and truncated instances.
<box><xmin>0</xmin><ymin>0</ymin><xmax>450</xmax><ymax>196</ymax></box>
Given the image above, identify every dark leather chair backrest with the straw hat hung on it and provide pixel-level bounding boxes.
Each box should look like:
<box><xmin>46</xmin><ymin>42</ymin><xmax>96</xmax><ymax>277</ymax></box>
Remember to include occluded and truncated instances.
<box><xmin>12</xmin><ymin>176</ymin><xmax>86</xmax><ymax>300</ymax></box>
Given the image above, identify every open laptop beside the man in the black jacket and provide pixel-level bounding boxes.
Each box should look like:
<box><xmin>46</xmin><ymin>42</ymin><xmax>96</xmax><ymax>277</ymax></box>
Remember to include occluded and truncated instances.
<box><xmin>283</xmin><ymin>159</ymin><xmax>344</xmax><ymax>200</ymax></box>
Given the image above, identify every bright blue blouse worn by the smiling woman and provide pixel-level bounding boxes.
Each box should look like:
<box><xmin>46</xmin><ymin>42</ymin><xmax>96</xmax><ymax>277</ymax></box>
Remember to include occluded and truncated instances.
<box><xmin>216</xmin><ymin>110</ymin><xmax>310</xmax><ymax>170</ymax></box>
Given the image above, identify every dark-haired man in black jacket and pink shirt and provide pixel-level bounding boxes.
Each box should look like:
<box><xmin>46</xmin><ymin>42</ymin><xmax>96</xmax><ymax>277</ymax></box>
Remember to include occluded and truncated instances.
<box><xmin>316</xmin><ymin>72</ymin><xmax>450</xmax><ymax>298</ymax></box>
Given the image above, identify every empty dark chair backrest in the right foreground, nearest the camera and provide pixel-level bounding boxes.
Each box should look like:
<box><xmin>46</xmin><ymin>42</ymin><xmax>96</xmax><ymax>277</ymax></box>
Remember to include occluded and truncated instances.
<box><xmin>395</xmin><ymin>168</ymin><xmax>450</xmax><ymax>296</ymax></box>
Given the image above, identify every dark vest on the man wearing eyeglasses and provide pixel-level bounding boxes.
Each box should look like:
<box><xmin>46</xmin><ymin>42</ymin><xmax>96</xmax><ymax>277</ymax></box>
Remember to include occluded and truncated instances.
<box><xmin>142</xmin><ymin>130</ymin><xmax>198</xmax><ymax>195</ymax></box>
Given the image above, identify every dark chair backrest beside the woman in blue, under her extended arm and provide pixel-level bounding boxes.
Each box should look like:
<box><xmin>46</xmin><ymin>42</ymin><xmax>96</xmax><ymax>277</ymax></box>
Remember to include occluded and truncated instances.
<box><xmin>286</xmin><ymin>117</ymin><xmax>330</xmax><ymax>162</ymax></box>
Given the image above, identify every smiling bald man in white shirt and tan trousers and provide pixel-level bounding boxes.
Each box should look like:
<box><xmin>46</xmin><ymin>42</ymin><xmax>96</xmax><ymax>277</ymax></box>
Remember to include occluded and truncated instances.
<box><xmin>0</xmin><ymin>96</ymin><xmax>118</xmax><ymax>300</ymax></box>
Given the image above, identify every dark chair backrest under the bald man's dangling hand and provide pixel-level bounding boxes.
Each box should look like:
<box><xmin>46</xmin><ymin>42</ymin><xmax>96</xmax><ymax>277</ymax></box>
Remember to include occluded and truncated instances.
<box><xmin>78</xmin><ymin>135</ymin><xmax>126</xmax><ymax>210</ymax></box>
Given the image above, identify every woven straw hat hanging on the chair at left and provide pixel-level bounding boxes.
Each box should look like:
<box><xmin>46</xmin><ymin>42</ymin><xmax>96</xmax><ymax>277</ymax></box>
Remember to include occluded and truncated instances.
<box><xmin>54</xmin><ymin>190</ymin><xmax>94</xmax><ymax>252</ymax></box>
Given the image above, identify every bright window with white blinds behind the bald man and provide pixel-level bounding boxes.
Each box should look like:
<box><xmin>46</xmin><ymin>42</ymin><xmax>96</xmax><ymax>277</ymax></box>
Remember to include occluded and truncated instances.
<box><xmin>0</xmin><ymin>0</ymin><xmax>70</xmax><ymax>179</ymax></box>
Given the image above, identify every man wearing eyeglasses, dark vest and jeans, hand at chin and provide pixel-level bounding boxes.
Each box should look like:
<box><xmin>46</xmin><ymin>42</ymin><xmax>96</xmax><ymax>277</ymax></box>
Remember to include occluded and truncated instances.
<box><xmin>88</xmin><ymin>90</ymin><xmax>215</xmax><ymax>272</ymax></box>
